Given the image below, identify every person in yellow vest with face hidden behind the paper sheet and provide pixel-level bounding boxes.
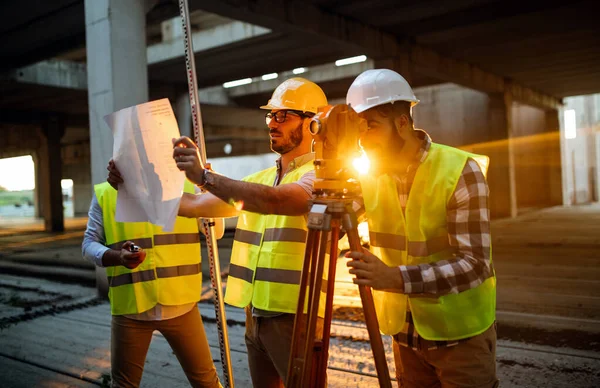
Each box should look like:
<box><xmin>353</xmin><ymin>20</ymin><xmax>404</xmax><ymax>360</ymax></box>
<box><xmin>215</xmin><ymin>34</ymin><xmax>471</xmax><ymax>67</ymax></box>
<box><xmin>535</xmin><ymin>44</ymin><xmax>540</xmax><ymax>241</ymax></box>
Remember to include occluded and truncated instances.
<box><xmin>82</xmin><ymin>180</ymin><xmax>222</xmax><ymax>388</ymax></box>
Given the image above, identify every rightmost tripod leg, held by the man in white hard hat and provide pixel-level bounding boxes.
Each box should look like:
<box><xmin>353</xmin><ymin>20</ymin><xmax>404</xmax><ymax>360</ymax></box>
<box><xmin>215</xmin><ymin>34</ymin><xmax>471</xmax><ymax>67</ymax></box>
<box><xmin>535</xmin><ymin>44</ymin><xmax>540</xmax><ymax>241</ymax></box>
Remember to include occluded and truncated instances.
<box><xmin>346</xmin><ymin>222</ymin><xmax>392</xmax><ymax>388</ymax></box>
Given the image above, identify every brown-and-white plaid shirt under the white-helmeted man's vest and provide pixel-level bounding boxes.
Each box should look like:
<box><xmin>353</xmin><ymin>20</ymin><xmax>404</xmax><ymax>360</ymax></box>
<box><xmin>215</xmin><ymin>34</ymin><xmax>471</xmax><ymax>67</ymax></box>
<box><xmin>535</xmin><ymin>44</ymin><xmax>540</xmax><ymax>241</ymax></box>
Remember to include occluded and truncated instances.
<box><xmin>394</xmin><ymin>130</ymin><xmax>494</xmax><ymax>350</ymax></box>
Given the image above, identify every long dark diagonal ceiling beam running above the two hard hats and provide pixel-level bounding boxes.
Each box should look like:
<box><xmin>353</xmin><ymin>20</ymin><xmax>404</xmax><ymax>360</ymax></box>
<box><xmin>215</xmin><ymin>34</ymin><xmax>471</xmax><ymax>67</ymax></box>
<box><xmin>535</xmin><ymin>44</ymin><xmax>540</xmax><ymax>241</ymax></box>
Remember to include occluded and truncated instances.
<box><xmin>196</xmin><ymin>0</ymin><xmax>562</xmax><ymax>109</ymax></box>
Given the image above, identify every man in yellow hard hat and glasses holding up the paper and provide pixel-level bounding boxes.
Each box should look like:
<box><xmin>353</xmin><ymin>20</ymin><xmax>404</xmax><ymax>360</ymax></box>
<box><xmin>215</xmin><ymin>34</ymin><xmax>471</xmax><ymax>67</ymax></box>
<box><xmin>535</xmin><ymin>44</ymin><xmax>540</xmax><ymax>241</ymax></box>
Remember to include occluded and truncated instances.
<box><xmin>113</xmin><ymin>77</ymin><xmax>327</xmax><ymax>388</ymax></box>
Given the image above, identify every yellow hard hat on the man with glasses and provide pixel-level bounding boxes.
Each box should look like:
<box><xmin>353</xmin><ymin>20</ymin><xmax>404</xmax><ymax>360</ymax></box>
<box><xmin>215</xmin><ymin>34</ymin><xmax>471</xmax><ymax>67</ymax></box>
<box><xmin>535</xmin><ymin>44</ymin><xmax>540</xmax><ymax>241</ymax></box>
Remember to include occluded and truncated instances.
<box><xmin>260</xmin><ymin>77</ymin><xmax>327</xmax><ymax>113</ymax></box>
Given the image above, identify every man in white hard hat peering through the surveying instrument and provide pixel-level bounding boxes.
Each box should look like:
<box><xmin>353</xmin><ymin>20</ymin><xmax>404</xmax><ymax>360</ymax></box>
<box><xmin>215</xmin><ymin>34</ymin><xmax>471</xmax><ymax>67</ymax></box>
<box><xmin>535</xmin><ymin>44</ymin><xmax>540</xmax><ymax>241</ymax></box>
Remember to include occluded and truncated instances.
<box><xmin>346</xmin><ymin>69</ymin><xmax>498</xmax><ymax>387</ymax></box>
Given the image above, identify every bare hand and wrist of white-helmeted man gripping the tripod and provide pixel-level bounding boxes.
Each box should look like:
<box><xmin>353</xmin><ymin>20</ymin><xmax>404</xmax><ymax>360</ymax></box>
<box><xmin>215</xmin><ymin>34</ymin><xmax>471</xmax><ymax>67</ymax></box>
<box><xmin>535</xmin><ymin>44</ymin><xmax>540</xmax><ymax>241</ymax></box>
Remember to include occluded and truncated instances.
<box><xmin>346</xmin><ymin>249</ymin><xmax>404</xmax><ymax>292</ymax></box>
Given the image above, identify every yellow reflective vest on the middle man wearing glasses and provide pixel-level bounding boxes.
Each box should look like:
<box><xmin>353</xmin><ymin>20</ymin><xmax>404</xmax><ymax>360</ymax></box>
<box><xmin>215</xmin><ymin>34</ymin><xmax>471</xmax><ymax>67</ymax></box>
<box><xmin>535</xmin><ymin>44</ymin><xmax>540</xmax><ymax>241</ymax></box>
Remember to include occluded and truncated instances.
<box><xmin>225</xmin><ymin>162</ymin><xmax>328</xmax><ymax>316</ymax></box>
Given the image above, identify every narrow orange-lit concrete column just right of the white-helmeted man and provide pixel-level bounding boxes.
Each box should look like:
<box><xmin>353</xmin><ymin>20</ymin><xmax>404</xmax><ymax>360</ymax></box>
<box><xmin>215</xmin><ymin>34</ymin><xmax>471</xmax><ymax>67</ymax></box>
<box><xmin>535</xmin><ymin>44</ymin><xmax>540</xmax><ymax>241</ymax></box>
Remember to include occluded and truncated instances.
<box><xmin>482</xmin><ymin>93</ymin><xmax>517</xmax><ymax>218</ymax></box>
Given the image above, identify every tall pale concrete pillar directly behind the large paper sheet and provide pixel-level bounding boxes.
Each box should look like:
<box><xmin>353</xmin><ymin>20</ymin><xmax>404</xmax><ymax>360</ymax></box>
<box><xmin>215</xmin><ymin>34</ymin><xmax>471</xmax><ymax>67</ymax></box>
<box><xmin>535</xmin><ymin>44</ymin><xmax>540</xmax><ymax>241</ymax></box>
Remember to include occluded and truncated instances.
<box><xmin>85</xmin><ymin>0</ymin><xmax>148</xmax><ymax>295</ymax></box>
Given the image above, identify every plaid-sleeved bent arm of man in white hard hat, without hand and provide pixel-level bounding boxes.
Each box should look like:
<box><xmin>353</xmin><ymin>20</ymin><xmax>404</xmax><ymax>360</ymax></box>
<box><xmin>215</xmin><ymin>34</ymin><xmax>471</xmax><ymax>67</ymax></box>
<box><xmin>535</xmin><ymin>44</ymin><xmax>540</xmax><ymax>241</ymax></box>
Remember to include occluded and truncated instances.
<box><xmin>399</xmin><ymin>159</ymin><xmax>493</xmax><ymax>296</ymax></box>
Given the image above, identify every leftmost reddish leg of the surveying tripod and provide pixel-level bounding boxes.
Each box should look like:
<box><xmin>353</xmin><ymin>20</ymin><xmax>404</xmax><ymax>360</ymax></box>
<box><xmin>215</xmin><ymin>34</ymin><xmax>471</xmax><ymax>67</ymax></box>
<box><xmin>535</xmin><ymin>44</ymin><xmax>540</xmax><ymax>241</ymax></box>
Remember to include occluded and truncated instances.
<box><xmin>285</xmin><ymin>229</ymin><xmax>321</xmax><ymax>387</ymax></box>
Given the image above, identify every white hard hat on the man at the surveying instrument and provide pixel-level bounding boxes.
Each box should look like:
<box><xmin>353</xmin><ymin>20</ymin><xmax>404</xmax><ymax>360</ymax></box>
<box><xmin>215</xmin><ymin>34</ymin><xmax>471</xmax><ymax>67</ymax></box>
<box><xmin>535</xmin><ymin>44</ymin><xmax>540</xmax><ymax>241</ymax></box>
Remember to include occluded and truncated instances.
<box><xmin>346</xmin><ymin>69</ymin><xmax>419</xmax><ymax>113</ymax></box>
